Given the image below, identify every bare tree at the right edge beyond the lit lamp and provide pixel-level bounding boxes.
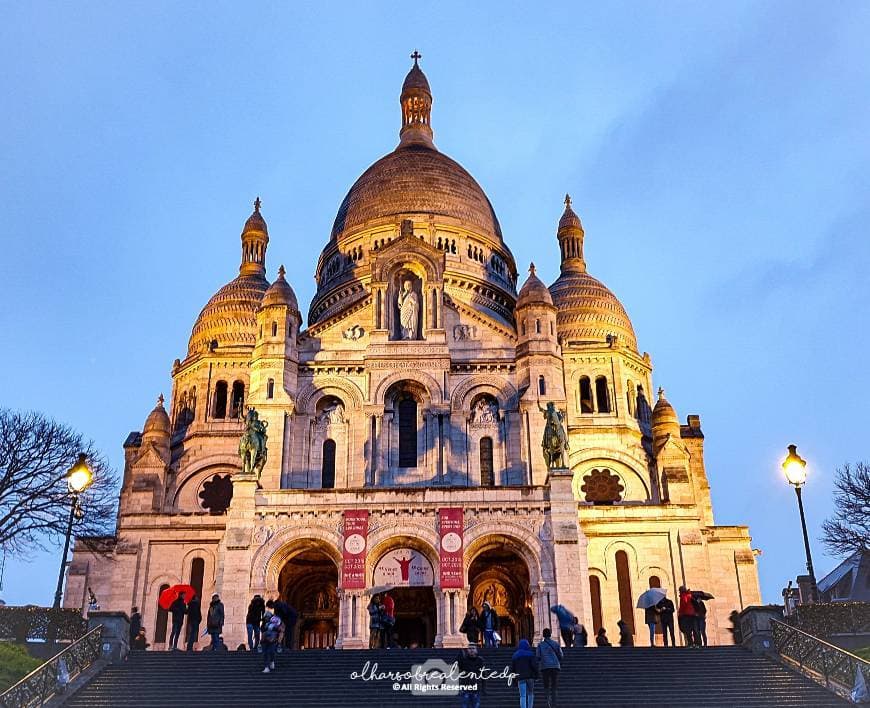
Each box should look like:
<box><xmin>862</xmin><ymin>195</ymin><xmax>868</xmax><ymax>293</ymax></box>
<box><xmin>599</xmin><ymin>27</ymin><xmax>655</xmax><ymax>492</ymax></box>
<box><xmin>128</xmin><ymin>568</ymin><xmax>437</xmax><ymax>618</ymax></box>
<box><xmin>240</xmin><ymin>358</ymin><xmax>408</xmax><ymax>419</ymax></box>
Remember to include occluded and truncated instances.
<box><xmin>822</xmin><ymin>462</ymin><xmax>870</xmax><ymax>556</ymax></box>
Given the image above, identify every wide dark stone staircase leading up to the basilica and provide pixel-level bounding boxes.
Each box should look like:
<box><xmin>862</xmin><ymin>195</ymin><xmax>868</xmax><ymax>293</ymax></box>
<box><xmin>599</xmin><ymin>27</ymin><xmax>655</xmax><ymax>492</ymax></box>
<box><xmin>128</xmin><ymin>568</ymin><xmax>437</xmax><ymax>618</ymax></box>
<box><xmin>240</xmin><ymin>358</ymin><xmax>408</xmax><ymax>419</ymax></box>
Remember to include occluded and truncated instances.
<box><xmin>66</xmin><ymin>647</ymin><xmax>849</xmax><ymax>708</ymax></box>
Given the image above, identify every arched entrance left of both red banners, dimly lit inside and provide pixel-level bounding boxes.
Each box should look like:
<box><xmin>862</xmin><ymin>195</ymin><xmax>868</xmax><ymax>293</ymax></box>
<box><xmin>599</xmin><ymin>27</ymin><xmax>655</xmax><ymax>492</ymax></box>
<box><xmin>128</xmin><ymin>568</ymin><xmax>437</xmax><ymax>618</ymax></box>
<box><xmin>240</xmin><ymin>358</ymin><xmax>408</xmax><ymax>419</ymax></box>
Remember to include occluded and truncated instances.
<box><xmin>278</xmin><ymin>548</ymin><xmax>338</xmax><ymax>649</ymax></box>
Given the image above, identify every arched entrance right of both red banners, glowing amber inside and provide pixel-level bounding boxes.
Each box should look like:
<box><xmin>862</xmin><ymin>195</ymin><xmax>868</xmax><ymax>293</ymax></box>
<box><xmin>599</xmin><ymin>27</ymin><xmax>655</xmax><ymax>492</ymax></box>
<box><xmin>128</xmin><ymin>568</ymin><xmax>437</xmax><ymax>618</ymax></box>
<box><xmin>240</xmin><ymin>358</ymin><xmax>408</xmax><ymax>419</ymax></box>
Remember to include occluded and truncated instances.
<box><xmin>468</xmin><ymin>538</ymin><xmax>535</xmax><ymax>646</ymax></box>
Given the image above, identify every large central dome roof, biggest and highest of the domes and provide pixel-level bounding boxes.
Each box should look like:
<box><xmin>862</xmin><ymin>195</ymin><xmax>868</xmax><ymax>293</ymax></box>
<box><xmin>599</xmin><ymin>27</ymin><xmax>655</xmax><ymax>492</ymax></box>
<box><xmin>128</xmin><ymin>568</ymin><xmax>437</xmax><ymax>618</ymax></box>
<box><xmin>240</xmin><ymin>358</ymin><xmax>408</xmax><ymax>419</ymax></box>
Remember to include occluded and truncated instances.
<box><xmin>332</xmin><ymin>144</ymin><xmax>501</xmax><ymax>241</ymax></box>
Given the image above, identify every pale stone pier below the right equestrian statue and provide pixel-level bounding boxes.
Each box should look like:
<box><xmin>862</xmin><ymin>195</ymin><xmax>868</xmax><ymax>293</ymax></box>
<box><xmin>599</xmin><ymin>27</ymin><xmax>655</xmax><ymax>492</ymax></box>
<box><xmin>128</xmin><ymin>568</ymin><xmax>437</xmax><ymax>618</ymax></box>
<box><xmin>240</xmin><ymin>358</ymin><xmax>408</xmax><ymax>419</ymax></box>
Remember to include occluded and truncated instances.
<box><xmin>546</xmin><ymin>468</ymin><xmax>592</xmax><ymax>627</ymax></box>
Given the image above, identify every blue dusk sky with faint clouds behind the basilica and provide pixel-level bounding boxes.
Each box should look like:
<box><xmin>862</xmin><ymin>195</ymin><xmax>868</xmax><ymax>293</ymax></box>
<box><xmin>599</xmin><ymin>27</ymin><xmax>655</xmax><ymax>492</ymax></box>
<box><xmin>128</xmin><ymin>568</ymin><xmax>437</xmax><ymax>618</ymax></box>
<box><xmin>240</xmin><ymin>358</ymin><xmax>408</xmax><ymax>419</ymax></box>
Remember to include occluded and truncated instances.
<box><xmin>0</xmin><ymin>1</ymin><xmax>870</xmax><ymax>603</ymax></box>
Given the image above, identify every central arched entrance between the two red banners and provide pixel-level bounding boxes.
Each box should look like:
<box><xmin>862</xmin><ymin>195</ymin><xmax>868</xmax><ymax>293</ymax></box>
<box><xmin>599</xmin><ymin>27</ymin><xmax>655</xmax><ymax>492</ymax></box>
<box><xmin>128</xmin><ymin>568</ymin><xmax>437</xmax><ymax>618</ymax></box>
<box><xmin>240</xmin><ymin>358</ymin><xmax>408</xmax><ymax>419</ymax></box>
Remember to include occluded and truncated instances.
<box><xmin>372</xmin><ymin>547</ymin><xmax>437</xmax><ymax>648</ymax></box>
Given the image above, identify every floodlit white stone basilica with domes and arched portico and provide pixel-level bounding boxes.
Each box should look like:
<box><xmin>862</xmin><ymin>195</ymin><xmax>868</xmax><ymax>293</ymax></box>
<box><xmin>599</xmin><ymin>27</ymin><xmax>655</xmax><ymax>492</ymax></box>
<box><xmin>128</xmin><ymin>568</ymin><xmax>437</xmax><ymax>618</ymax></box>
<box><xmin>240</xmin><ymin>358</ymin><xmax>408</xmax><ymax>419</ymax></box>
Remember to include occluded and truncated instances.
<box><xmin>64</xmin><ymin>58</ymin><xmax>760</xmax><ymax>649</ymax></box>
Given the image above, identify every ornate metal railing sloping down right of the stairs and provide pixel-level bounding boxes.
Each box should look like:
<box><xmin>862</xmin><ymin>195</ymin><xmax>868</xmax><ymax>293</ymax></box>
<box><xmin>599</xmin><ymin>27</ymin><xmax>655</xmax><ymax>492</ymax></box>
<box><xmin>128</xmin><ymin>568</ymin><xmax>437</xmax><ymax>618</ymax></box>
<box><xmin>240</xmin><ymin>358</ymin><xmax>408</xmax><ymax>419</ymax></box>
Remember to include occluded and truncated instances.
<box><xmin>770</xmin><ymin>619</ymin><xmax>870</xmax><ymax>699</ymax></box>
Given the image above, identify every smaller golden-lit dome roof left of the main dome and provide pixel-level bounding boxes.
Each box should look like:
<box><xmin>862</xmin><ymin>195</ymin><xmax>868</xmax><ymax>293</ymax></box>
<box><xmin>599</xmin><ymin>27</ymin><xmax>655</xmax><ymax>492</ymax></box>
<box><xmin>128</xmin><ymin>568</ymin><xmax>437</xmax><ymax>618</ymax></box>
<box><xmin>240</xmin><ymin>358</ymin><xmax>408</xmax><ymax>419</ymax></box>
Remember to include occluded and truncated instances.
<box><xmin>187</xmin><ymin>273</ymin><xmax>269</xmax><ymax>356</ymax></box>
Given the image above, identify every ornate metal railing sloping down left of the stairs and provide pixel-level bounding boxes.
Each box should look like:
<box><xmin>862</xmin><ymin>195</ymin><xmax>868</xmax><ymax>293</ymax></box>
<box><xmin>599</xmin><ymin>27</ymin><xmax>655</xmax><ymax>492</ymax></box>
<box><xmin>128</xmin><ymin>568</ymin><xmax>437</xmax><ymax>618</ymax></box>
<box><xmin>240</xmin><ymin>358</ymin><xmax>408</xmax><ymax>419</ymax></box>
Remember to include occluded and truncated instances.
<box><xmin>0</xmin><ymin>625</ymin><xmax>103</xmax><ymax>708</ymax></box>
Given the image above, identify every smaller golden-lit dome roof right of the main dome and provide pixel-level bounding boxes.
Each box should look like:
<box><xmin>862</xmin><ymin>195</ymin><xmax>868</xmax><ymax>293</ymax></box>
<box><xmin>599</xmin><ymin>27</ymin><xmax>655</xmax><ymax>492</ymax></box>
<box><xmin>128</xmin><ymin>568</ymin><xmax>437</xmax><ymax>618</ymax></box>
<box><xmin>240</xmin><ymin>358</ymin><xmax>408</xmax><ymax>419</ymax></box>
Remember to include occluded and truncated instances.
<box><xmin>550</xmin><ymin>269</ymin><xmax>637</xmax><ymax>351</ymax></box>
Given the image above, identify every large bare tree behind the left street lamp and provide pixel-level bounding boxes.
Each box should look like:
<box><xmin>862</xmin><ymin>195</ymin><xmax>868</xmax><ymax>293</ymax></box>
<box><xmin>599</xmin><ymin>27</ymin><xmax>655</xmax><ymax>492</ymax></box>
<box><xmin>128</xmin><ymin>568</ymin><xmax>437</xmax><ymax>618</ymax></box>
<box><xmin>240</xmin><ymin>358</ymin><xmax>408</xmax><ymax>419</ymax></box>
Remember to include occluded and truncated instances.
<box><xmin>0</xmin><ymin>408</ymin><xmax>117</xmax><ymax>556</ymax></box>
